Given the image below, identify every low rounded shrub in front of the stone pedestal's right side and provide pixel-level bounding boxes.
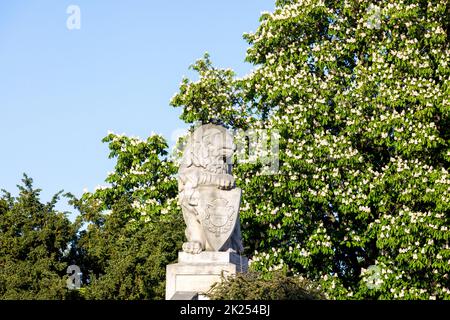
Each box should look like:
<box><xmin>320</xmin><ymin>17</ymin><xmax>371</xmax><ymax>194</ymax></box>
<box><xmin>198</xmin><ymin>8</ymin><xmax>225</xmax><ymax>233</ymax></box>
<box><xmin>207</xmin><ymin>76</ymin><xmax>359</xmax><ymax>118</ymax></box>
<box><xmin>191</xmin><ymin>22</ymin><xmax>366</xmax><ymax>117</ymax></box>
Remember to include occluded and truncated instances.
<box><xmin>207</xmin><ymin>272</ymin><xmax>325</xmax><ymax>300</ymax></box>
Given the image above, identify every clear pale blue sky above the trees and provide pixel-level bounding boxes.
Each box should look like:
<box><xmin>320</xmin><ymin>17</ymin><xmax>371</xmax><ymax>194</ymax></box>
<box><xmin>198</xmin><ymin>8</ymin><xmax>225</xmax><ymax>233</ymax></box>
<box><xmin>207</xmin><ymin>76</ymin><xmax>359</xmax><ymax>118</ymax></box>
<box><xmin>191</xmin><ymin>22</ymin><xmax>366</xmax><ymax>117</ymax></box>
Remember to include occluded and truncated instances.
<box><xmin>0</xmin><ymin>0</ymin><xmax>274</xmax><ymax>220</ymax></box>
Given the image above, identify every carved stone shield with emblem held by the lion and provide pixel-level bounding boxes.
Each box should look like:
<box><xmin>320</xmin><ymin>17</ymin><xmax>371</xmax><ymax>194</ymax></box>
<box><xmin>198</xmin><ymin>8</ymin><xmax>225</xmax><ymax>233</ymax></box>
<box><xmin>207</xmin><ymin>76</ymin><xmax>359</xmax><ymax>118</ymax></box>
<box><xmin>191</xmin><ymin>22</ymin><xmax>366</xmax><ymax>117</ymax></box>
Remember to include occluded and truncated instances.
<box><xmin>198</xmin><ymin>186</ymin><xmax>242</xmax><ymax>251</ymax></box>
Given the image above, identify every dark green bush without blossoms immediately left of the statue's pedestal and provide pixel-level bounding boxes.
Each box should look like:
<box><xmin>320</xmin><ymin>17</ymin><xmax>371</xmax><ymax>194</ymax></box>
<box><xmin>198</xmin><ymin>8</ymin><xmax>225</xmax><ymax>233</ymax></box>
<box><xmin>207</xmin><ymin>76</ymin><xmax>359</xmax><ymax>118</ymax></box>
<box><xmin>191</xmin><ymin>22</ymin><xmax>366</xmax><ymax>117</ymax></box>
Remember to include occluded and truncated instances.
<box><xmin>79</xmin><ymin>209</ymin><xmax>183</xmax><ymax>300</ymax></box>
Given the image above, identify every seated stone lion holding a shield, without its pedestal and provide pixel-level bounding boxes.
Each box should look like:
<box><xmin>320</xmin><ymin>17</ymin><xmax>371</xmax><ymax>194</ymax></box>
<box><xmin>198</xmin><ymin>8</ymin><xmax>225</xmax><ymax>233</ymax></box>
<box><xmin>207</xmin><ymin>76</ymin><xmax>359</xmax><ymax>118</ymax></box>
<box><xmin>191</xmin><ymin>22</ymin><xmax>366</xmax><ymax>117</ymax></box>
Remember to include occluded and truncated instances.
<box><xmin>178</xmin><ymin>124</ymin><xmax>243</xmax><ymax>254</ymax></box>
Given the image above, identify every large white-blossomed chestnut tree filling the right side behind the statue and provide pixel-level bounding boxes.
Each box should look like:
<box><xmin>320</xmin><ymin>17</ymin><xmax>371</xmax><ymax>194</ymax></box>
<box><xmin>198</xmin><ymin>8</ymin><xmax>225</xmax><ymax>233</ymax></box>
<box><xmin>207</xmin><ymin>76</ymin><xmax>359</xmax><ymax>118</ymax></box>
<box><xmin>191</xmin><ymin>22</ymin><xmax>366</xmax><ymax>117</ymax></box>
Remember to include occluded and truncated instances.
<box><xmin>172</xmin><ymin>0</ymin><xmax>450</xmax><ymax>299</ymax></box>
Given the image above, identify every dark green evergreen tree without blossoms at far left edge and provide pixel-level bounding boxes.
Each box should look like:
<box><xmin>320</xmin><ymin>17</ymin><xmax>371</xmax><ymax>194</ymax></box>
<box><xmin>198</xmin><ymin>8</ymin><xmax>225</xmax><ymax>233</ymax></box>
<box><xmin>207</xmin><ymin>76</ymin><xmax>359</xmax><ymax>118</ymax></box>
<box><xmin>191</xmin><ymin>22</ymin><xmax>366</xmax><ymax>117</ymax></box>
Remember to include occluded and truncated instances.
<box><xmin>0</xmin><ymin>175</ymin><xmax>76</xmax><ymax>300</ymax></box>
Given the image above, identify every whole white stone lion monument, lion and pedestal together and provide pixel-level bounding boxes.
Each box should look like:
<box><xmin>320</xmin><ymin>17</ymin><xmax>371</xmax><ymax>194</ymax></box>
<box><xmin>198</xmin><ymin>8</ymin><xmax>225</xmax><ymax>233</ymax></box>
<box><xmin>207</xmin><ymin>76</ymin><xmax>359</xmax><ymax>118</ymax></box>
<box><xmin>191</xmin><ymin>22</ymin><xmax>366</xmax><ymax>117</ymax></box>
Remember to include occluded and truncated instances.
<box><xmin>166</xmin><ymin>124</ymin><xmax>248</xmax><ymax>300</ymax></box>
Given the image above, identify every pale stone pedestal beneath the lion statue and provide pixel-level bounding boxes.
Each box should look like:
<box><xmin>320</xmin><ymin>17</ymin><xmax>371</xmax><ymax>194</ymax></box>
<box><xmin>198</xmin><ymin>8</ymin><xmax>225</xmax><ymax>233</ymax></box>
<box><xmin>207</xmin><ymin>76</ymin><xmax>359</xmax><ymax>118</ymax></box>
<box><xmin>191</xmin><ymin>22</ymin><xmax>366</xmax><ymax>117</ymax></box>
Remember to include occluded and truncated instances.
<box><xmin>166</xmin><ymin>251</ymin><xmax>248</xmax><ymax>300</ymax></box>
